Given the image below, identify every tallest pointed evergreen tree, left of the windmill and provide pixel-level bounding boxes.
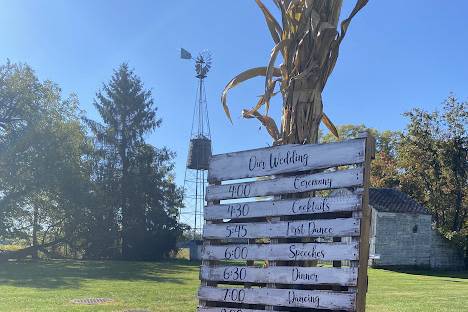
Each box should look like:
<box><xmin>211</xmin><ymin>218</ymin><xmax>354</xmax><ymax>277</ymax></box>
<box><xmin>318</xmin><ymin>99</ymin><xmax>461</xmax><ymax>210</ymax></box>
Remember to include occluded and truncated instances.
<box><xmin>88</xmin><ymin>63</ymin><xmax>184</xmax><ymax>259</ymax></box>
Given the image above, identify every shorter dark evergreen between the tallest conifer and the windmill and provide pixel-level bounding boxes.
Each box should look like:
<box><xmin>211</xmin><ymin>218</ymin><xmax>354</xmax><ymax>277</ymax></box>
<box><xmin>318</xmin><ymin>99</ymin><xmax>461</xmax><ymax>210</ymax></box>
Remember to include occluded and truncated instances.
<box><xmin>129</xmin><ymin>144</ymin><xmax>184</xmax><ymax>260</ymax></box>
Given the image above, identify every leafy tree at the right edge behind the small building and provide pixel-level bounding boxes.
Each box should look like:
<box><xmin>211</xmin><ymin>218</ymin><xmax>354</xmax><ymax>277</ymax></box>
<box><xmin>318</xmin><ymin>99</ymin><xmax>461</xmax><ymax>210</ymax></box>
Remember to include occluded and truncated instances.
<box><xmin>398</xmin><ymin>96</ymin><xmax>468</xmax><ymax>236</ymax></box>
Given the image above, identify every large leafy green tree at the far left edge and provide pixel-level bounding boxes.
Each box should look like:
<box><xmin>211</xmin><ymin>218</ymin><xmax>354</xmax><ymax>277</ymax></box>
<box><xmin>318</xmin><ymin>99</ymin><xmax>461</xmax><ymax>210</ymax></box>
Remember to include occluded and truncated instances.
<box><xmin>0</xmin><ymin>63</ymin><xmax>89</xmax><ymax>257</ymax></box>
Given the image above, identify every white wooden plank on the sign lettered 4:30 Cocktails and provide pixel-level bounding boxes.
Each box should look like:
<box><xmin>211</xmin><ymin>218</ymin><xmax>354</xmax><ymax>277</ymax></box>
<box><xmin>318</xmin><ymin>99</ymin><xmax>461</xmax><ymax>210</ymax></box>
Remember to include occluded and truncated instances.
<box><xmin>204</xmin><ymin>195</ymin><xmax>362</xmax><ymax>220</ymax></box>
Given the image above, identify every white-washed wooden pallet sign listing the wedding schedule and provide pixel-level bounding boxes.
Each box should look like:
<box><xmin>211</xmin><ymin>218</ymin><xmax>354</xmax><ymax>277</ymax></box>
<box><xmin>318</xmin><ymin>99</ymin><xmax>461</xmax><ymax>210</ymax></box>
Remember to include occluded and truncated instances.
<box><xmin>198</xmin><ymin>133</ymin><xmax>374</xmax><ymax>312</ymax></box>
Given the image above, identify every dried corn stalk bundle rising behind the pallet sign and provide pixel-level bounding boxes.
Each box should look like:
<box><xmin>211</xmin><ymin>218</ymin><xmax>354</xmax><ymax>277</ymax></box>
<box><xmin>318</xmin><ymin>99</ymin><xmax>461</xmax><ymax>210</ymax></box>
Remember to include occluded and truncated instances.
<box><xmin>221</xmin><ymin>0</ymin><xmax>368</xmax><ymax>144</ymax></box>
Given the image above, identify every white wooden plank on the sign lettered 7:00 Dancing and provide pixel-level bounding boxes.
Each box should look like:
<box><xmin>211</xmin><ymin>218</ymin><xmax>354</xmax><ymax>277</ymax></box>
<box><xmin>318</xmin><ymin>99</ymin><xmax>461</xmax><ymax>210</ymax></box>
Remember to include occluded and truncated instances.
<box><xmin>198</xmin><ymin>287</ymin><xmax>356</xmax><ymax>311</ymax></box>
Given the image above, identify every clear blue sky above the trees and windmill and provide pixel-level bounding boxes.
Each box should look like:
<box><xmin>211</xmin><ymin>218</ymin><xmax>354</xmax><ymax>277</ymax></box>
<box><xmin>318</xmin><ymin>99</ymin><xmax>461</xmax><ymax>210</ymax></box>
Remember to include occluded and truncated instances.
<box><xmin>0</xmin><ymin>0</ymin><xmax>468</xmax><ymax>188</ymax></box>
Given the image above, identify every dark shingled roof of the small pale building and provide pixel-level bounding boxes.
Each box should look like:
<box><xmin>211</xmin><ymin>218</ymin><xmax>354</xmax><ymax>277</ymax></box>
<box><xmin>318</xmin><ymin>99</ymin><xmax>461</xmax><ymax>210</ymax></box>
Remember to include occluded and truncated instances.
<box><xmin>369</xmin><ymin>188</ymin><xmax>429</xmax><ymax>214</ymax></box>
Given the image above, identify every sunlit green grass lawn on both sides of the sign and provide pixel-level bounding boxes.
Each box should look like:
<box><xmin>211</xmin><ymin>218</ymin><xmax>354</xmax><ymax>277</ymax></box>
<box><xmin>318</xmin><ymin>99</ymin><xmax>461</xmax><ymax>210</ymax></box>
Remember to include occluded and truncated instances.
<box><xmin>0</xmin><ymin>261</ymin><xmax>468</xmax><ymax>312</ymax></box>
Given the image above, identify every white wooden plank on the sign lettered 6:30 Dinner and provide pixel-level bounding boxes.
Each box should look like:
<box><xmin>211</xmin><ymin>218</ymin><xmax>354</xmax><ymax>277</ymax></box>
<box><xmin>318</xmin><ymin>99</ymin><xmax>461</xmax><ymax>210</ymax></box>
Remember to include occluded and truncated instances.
<box><xmin>200</xmin><ymin>266</ymin><xmax>358</xmax><ymax>286</ymax></box>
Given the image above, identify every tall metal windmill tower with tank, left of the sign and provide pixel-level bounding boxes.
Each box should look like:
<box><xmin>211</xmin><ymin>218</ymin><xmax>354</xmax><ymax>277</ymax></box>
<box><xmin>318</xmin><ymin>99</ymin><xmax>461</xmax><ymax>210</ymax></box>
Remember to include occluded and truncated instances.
<box><xmin>179</xmin><ymin>49</ymin><xmax>211</xmax><ymax>238</ymax></box>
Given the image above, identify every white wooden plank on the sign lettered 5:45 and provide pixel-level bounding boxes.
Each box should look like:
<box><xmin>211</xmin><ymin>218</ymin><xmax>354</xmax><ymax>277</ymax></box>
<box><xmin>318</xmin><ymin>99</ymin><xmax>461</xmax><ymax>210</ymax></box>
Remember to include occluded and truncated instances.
<box><xmin>203</xmin><ymin>218</ymin><xmax>360</xmax><ymax>239</ymax></box>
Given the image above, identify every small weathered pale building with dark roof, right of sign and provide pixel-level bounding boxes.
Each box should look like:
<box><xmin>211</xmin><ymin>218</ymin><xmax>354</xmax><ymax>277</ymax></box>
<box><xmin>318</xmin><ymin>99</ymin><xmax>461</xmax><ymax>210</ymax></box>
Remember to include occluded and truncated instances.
<box><xmin>369</xmin><ymin>188</ymin><xmax>464</xmax><ymax>270</ymax></box>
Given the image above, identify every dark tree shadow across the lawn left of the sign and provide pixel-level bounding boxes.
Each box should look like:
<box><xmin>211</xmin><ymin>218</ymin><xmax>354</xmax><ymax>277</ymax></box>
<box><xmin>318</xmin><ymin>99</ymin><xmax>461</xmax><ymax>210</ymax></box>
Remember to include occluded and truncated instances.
<box><xmin>0</xmin><ymin>260</ymin><xmax>199</xmax><ymax>289</ymax></box>
